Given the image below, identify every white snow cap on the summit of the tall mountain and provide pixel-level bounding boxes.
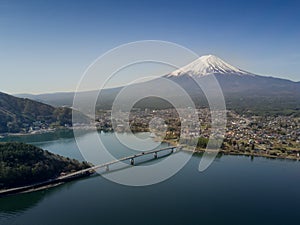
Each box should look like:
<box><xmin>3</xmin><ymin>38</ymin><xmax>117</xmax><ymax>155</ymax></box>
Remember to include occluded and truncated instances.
<box><xmin>169</xmin><ymin>55</ymin><xmax>249</xmax><ymax>76</ymax></box>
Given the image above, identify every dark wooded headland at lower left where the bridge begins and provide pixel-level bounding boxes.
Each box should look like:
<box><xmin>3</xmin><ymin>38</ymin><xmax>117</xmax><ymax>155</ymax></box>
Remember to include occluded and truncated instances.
<box><xmin>0</xmin><ymin>143</ymin><xmax>89</xmax><ymax>189</ymax></box>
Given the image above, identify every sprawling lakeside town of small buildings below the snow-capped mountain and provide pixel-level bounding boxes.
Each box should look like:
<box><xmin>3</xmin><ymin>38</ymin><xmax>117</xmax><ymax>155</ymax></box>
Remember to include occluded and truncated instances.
<box><xmin>96</xmin><ymin>108</ymin><xmax>300</xmax><ymax>159</ymax></box>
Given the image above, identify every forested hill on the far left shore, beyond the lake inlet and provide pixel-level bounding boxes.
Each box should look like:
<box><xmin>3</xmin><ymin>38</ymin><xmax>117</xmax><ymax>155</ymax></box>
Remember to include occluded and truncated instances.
<box><xmin>0</xmin><ymin>92</ymin><xmax>72</xmax><ymax>133</ymax></box>
